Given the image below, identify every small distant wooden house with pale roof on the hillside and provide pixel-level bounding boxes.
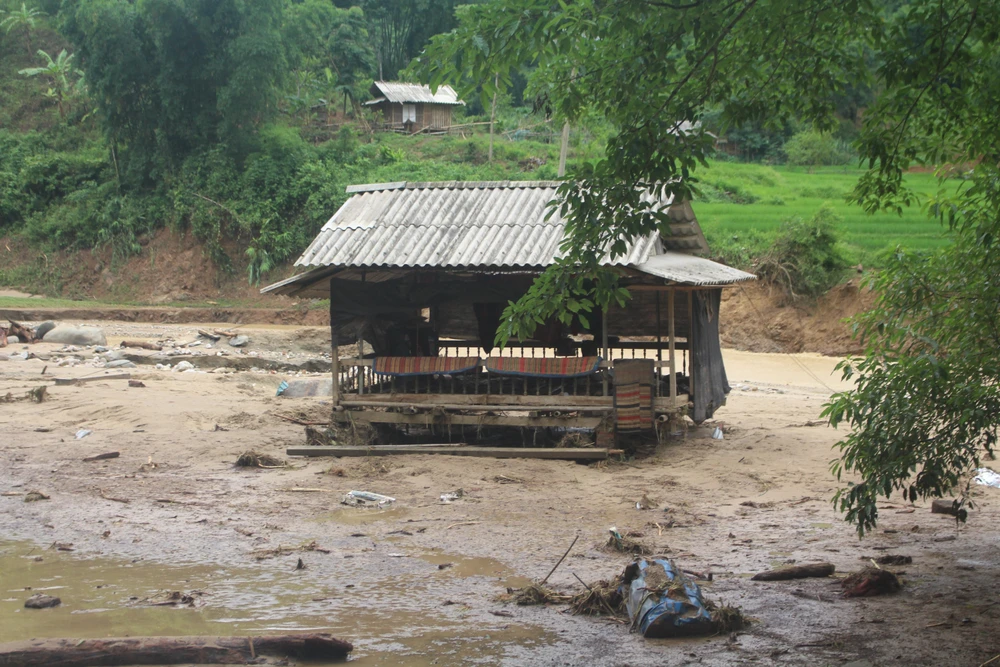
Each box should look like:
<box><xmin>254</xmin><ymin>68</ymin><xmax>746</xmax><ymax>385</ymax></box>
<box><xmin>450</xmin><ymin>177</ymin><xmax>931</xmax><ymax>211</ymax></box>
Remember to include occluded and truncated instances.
<box><xmin>365</xmin><ymin>81</ymin><xmax>465</xmax><ymax>134</ymax></box>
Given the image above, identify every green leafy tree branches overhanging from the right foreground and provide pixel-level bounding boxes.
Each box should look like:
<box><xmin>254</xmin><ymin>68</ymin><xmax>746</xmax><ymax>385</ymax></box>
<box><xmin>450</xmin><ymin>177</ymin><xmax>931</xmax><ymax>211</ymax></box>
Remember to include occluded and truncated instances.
<box><xmin>416</xmin><ymin>0</ymin><xmax>1000</xmax><ymax>533</ymax></box>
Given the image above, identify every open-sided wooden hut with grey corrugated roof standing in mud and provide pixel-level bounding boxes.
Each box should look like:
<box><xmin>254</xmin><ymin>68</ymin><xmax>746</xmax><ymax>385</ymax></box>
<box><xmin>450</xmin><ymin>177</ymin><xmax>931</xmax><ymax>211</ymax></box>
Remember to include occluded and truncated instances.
<box><xmin>262</xmin><ymin>181</ymin><xmax>754</xmax><ymax>452</ymax></box>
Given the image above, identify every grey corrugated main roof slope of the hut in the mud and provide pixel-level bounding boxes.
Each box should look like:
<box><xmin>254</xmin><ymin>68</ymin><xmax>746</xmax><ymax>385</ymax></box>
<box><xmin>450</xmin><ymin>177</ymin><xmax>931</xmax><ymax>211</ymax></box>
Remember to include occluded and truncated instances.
<box><xmin>295</xmin><ymin>181</ymin><xmax>672</xmax><ymax>268</ymax></box>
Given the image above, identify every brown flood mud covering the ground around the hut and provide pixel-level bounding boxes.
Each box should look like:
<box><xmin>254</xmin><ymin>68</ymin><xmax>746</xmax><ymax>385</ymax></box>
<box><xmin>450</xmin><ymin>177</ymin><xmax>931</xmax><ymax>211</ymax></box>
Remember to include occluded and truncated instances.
<box><xmin>0</xmin><ymin>323</ymin><xmax>1000</xmax><ymax>665</ymax></box>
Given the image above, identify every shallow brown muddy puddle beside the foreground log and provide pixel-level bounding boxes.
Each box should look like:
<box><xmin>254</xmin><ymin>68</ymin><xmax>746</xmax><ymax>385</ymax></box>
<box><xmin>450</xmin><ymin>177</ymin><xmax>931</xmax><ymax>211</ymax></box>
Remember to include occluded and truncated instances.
<box><xmin>0</xmin><ymin>542</ymin><xmax>558</xmax><ymax>666</ymax></box>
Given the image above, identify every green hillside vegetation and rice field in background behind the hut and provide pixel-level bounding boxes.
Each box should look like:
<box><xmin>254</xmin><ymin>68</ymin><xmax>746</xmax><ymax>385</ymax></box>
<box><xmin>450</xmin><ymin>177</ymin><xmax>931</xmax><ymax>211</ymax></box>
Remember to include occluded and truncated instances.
<box><xmin>0</xmin><ymin>0</ymin><xmax>944</xmax><ymax>298</ymax></box>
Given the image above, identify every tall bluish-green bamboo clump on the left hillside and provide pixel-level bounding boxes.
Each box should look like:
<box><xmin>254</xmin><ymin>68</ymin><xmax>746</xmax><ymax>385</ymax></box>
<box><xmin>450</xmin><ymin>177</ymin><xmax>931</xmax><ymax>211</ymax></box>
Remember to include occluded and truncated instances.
<box><xmin>63</xmin><ymin>0</ymin><xmax>285</xmax><ymax>183</ymax></box>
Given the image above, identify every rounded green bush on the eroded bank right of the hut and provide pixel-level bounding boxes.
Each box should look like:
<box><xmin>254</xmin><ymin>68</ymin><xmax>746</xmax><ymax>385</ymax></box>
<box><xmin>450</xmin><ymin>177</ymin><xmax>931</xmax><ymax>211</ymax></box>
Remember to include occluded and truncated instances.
<box><xmin>756</xmin><ymin>205</ymin><xmax>848</xmax><ymax>299</ymax></box>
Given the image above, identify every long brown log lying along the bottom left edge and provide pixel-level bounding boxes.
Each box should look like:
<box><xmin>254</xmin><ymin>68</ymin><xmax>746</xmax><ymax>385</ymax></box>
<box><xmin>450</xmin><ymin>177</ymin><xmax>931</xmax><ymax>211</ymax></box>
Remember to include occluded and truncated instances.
<box><xmin>0</xmin><ymin>634</ymin><xmax>354</xmax><ymax>667</ymax></box>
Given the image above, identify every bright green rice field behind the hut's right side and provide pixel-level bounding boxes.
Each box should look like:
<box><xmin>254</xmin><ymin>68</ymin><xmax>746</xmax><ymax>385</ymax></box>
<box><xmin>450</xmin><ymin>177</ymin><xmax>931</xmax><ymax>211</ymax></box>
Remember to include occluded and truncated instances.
<box><xmin>695</xmin><ymin>162</ymin><xmax>957</xmax><ymax>266</ymax></box>
